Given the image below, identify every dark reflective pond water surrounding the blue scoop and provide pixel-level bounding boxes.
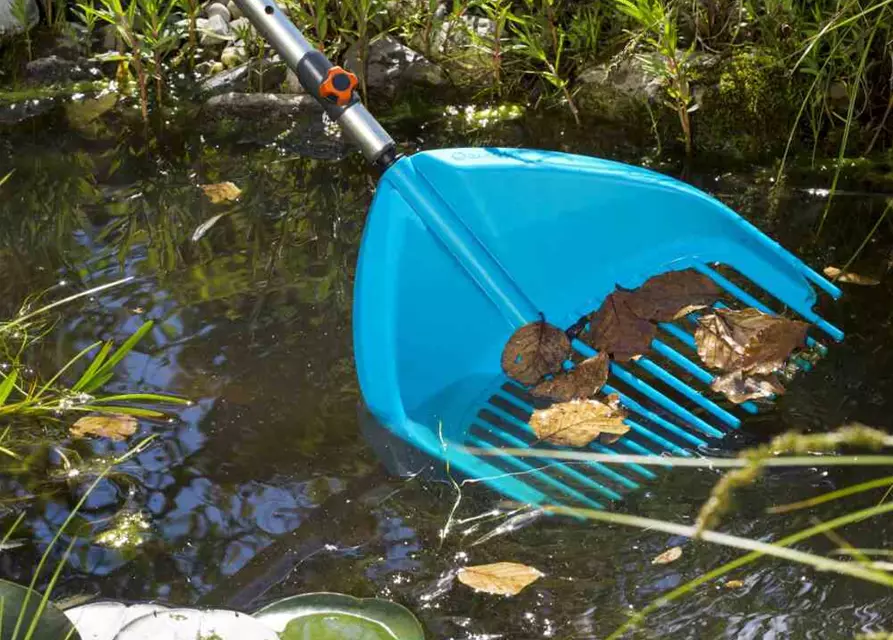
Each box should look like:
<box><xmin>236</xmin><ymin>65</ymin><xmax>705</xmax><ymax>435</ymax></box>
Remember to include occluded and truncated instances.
<box><xmin>0</xmin><ymin>96</ymin><xmax>893</xmax><ymax>640</ymax></box>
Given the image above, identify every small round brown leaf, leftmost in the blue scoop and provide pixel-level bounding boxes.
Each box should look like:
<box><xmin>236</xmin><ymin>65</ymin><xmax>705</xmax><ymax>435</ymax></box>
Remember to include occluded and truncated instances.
<box><xmin>502</xmin><ymin>322</ymin><xmax>571</xmax><ymax>384</ymax></box>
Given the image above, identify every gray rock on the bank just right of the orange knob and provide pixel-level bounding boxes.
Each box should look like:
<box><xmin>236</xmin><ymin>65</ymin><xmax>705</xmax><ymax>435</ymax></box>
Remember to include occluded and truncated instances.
<box><xmin>344</xmin><ymin>36</ymin><xmax>444</xmax><ymax>95</ymax></box>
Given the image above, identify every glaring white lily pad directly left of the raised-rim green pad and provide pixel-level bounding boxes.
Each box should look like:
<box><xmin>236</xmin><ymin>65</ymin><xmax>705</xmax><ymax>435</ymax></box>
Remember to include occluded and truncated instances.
<box><xmin>114</xmin><ymin>609</ymin><xmax>279</xmax><ymax>640</ymax></box>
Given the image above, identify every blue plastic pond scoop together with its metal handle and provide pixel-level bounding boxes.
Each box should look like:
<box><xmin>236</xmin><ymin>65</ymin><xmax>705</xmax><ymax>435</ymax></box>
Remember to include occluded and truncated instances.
<box><xmin>239</xmin><ymin>0</ymin><xmax>843</xmax><ymax>507</ymax></box>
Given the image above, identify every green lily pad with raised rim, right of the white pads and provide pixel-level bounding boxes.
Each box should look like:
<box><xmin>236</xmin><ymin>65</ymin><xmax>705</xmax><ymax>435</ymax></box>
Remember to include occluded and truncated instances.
<box><xmin>254</xmin><ymin>593</ymin><xmax>425</xmax><ymax>640</ymax></box>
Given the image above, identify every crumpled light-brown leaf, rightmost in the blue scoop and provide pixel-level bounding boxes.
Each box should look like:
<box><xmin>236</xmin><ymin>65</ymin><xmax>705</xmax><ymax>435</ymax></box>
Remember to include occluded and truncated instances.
<box><xmin>695</xmin><ymin>309</ymin><xmax>809</xmax><ymax>373</ymax></box>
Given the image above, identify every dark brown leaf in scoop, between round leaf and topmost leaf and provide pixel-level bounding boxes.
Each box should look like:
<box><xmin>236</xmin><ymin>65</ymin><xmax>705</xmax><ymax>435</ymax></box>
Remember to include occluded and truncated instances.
<box><xmin>580</xmin><ymin>291</ymin><xmax>657</xmax><ymax>362</ymax></box>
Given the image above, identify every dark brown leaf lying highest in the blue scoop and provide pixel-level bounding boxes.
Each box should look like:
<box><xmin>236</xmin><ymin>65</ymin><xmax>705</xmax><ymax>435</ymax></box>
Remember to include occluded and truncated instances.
<box><xmin>627</xmin><ymin>269</ymin><xmax>722</xmax><ymax>322</ymax></box>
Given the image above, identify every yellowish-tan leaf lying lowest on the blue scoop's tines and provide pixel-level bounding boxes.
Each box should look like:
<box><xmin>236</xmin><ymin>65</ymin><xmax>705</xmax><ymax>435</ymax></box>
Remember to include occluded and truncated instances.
<box><xmin>530</xmin><ymin>395</ymin><xmax>629</xmax><ymax>447</ymax></box>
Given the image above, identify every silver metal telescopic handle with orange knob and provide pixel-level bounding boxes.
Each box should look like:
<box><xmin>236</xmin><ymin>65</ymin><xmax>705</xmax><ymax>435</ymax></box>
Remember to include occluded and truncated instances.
<box><xmin>235</xmin><ymin>0</ymin><xmax>395</xmax><ymax>168</ymax></box>
